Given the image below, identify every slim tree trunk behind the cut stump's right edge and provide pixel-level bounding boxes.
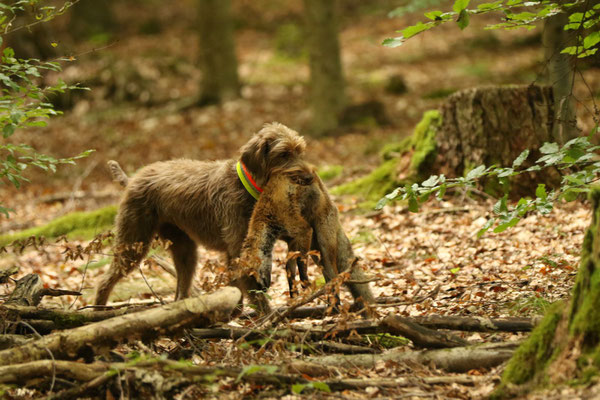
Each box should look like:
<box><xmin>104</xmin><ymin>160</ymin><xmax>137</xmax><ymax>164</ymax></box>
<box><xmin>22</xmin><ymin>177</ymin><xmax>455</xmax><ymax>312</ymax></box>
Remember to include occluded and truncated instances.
<box><xmin>542</xmin><ymin>13</ymin><xmax>578</xmax><ymax>143</ymax></box>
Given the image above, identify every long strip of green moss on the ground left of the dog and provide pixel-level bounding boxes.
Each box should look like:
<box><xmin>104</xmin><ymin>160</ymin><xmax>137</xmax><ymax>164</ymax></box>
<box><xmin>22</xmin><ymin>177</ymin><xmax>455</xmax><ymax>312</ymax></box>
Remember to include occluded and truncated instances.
<box><xmin>0</xmin><ymin>206</ymin><xmax>117</xmax><ymax>246</ymax></box>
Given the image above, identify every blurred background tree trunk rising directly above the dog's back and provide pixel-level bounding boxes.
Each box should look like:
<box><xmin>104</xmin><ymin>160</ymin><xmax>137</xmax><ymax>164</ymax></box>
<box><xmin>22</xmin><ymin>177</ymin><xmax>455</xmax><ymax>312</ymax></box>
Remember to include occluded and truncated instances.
<box><xmin>198</xmin><ymin>0</ymin><xmax>240</xmax><ymax>104</ymax></box>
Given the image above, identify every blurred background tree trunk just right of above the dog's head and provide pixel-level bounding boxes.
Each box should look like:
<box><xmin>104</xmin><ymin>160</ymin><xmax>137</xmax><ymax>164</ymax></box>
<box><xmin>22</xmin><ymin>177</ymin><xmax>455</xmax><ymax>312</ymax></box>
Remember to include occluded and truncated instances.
<box><xmin>304</xmin><ymin>0</ymin><xmax>345</xmax><ymax>135</ymax></box>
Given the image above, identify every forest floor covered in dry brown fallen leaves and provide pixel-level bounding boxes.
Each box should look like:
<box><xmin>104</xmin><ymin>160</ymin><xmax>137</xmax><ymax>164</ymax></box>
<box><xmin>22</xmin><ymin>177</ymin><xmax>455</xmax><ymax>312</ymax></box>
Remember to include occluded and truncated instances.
<box><xmin>0</xmin><ymin>1</ymin><xmax>600</xmax><ymax>399</ymax></box>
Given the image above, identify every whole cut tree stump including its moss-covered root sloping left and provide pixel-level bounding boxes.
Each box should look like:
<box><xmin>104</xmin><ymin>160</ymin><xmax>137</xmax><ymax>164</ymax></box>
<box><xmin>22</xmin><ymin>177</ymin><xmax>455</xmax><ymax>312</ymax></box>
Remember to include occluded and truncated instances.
<box><xmin>332</xmin><ymin>85</ymin><xmax>560</xmax><ymax>201</ymax></box>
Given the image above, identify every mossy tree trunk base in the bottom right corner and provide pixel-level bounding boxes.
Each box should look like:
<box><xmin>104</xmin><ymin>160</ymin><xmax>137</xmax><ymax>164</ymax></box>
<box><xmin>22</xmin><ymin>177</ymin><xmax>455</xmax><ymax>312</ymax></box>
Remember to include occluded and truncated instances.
<box><xmin>495</xmin><ymin>187</ymin><xmax>600</xmax><ymax>398</ymax></box>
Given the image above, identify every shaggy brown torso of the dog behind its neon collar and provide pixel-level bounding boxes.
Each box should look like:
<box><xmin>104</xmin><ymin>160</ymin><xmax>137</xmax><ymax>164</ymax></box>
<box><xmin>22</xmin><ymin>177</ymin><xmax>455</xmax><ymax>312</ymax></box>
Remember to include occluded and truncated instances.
<box><xmin>121</xmin><ymin>159</ymin><xmax>254</xmax><ymax>255</ymax></box>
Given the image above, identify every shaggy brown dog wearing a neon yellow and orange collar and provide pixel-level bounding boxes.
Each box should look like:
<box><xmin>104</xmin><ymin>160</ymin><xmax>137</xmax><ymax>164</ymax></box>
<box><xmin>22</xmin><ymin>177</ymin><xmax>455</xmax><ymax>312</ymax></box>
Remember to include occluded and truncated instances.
<box><xmin>95</xmin><ymin>123</ymin><xmax>307</xmax><ymax>305</ymax></box>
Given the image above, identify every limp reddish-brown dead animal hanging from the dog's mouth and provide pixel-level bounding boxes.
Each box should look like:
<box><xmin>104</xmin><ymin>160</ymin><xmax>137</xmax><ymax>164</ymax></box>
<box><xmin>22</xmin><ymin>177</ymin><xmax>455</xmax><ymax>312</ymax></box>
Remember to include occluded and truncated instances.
<box><xmin>239</xmin><ymin>166</ymin><xmax>374</xmax><ymax>315</ymax></box>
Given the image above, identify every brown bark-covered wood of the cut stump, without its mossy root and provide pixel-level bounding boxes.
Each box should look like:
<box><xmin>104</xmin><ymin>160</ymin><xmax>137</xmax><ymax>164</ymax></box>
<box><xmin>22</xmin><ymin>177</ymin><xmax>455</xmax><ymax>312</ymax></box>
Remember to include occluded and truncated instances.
<box><xmin>432</xmin><ymin>85</ymin><xmax>560</xmax><ymax>195</ymax></box>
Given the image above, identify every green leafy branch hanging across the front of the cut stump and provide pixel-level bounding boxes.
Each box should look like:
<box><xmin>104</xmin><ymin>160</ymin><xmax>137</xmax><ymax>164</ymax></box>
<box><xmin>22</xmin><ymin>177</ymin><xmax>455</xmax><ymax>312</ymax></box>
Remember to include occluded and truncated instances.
<box><xmin>376</xmin><ymin>128</ymin><xmax>600</xmax><ymax>236</ymax></box>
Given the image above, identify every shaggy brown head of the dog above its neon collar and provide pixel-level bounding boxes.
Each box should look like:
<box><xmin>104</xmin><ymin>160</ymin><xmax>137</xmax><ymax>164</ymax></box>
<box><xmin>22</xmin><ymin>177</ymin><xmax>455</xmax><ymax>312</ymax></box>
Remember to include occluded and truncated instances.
<box><xmin>240</xmin><ymin>122</ymin><xmax>306</xmax><ymax>185</ymax></box>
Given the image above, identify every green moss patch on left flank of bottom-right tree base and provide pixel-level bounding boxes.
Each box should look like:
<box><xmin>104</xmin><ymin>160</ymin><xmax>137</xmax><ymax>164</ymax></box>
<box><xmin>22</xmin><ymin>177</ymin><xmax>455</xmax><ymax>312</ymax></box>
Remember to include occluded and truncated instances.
<box><xmin>501</xmin><ymin>302</ymin><xmax>564</xmax><ymax>386</ymax></box>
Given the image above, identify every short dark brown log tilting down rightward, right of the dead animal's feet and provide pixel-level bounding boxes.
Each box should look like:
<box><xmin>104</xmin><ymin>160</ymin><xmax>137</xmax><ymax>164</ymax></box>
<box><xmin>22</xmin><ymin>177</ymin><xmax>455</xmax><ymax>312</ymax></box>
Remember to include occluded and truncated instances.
<box><xmin>380</xmin><ymin>314</ymin><xmax>468</xmax><ymax>349</ymax></box>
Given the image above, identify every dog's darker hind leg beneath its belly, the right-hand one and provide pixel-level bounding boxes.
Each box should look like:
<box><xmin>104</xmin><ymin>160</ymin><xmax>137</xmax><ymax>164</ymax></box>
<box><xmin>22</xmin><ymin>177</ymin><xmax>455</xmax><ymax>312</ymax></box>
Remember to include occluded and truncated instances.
<box><xmin>158</xmin><ymin>224</ymin><xmax>198</xmax><ymax>300</ymax></box>
